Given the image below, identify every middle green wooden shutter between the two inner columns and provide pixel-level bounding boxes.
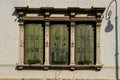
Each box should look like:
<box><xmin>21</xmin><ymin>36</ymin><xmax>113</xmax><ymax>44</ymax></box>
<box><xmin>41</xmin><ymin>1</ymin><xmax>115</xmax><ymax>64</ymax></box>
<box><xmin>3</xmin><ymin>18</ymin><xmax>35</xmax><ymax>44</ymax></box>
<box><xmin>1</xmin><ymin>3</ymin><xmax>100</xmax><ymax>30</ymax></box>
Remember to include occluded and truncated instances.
<box><xmin>50</xmin><ymin>24</ymin><xmax>69</xmax><ymax>64</ymax></box>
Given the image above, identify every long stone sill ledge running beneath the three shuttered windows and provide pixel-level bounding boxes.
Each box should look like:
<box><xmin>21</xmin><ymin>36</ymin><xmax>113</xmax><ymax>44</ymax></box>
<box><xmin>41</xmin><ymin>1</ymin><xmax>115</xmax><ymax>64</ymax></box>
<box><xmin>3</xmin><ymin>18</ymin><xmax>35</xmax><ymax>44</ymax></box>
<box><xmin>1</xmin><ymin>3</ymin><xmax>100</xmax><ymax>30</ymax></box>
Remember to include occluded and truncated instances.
<box><xmin>16</xmin><ymin>64</ymin><xmax>103</xmax><ymax>71</ymax></box>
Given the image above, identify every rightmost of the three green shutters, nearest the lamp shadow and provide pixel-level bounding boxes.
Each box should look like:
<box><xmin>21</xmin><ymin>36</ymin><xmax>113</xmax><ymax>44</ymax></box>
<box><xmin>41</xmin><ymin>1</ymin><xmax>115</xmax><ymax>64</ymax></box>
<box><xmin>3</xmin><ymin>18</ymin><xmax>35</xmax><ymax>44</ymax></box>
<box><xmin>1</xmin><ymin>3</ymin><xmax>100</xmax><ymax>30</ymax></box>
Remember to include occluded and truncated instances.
<box><xmin>76</xmin><ymin>24</ymin><xmax>94</xmax><ymax>64</ymax></box>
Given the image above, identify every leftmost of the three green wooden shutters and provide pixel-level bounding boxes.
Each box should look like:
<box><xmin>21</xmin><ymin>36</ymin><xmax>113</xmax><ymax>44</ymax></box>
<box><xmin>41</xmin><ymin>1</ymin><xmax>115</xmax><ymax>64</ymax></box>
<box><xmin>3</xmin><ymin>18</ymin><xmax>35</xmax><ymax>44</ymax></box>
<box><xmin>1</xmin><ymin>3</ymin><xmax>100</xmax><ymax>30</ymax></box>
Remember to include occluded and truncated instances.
<box><xmin>25</xmin><ymin>23</ymin><xmax>43</xmax><ymax>63</ymax></box>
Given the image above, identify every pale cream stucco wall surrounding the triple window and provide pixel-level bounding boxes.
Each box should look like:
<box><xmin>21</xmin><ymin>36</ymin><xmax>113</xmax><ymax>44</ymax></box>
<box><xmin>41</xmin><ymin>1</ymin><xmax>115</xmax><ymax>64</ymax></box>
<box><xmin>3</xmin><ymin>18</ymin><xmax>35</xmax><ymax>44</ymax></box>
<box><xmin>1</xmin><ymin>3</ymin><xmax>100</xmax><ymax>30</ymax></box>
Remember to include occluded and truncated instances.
<box><xmin>0</xmin><ymin>0</ymin><xmax>120</xmax><ymax>79</ymax></box>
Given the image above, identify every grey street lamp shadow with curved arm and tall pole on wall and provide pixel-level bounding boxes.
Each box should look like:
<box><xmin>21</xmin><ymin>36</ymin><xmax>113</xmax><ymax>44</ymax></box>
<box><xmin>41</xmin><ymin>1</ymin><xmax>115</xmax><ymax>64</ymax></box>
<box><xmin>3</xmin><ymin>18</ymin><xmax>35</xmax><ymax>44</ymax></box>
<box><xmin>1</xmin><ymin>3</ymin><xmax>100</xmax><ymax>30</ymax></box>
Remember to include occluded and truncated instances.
<box><xmin>105</xmin><ymin>0</ymin><xmax>119</xmax><ymax>80</ymax></box>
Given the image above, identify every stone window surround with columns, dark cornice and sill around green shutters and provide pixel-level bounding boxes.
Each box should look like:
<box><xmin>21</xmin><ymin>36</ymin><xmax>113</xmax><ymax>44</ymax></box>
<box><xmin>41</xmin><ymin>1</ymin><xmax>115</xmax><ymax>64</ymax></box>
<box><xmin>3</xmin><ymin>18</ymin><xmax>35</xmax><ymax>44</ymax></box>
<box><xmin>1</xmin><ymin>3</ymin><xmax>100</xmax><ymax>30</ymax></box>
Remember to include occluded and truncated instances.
<box><xmin>15</xmin><ymin>7</ymin><xmax>105</xmax><ymax>70</ymax></box>
